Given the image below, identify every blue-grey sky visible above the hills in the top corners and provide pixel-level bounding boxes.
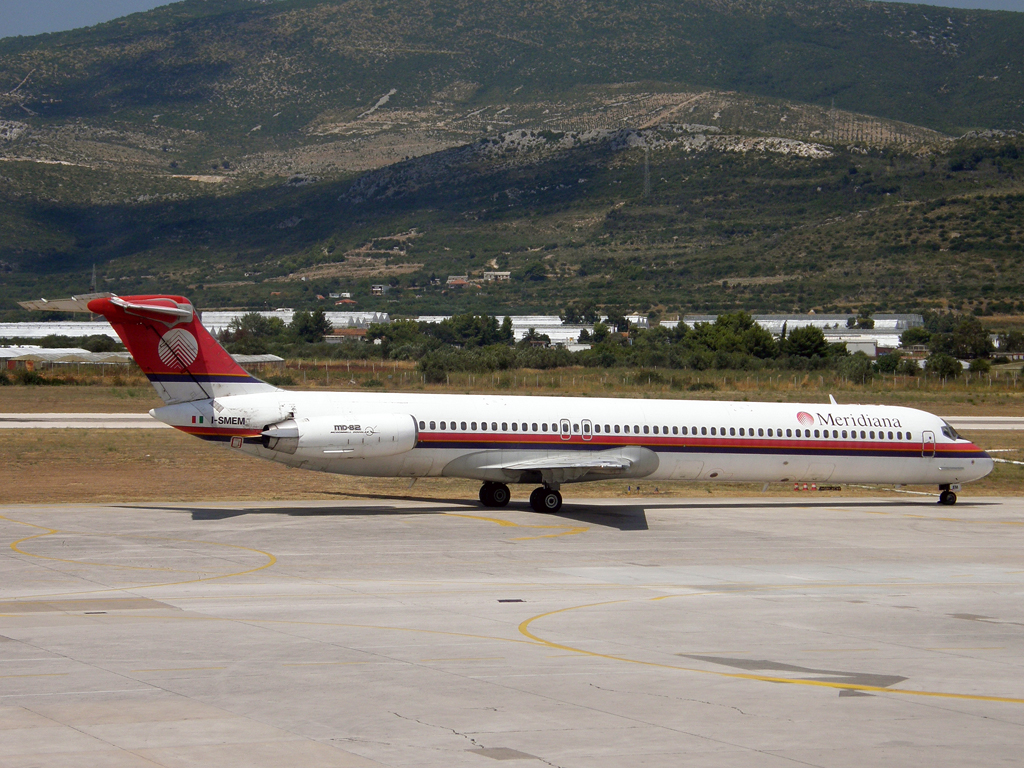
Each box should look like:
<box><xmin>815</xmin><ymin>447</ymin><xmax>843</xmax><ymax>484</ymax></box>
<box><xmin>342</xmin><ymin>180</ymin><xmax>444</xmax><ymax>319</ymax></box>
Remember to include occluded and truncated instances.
<box><xmin>0</xmin><ymin>0</ymin><xmax>1024</xmax><ymax>38</ymax></box>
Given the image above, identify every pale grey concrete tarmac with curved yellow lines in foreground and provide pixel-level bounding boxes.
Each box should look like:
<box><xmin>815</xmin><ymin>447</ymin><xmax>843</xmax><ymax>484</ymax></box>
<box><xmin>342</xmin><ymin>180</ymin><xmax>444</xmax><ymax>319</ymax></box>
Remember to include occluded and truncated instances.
<box><xmin>0</xmin><ymin>495</ymin><xmax>1024</xmax><ymax>768</ymax></box>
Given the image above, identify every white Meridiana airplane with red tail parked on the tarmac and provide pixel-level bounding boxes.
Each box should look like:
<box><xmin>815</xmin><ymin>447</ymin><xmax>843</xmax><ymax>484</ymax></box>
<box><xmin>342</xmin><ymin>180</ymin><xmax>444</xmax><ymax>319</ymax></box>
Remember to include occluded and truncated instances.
<box><xmin>20</xmin><ymin>293</ymin><xmax>993</xmax><ymax>513</ymax></box>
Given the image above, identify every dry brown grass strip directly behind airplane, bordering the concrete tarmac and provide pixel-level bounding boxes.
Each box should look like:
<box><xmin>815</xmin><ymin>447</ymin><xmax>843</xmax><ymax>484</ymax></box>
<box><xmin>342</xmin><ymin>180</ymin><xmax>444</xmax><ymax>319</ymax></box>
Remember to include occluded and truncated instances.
<box><xmin>0</xmin><ymin>429</ymin><xmax>1024</xmax><ymax>504</ymax></box>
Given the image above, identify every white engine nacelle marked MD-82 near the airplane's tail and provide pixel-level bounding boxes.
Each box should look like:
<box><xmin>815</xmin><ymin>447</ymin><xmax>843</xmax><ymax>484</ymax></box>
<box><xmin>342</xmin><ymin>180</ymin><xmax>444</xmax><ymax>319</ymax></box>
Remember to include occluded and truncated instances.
<box><xmin>262</xmin><ymin>414</ymin><xmax>419</xmax><ymax>459</ymax></box>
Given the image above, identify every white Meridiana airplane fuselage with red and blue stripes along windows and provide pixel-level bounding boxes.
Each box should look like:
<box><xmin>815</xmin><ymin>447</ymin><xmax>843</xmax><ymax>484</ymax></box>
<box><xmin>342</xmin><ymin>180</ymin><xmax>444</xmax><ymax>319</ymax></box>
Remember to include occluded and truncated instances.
<box><xmin>153</xmin><ymin>390</ymin><xmax>992</xmax><ymax>486</ymax></box>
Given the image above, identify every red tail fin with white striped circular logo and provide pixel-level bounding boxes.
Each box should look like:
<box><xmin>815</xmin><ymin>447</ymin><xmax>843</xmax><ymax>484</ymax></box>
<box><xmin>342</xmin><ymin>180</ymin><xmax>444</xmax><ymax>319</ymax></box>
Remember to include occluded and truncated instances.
<box><xmin>88</xmin><ymin>296</ymin><xmax>274</xmax><ymax>403</ymax></box>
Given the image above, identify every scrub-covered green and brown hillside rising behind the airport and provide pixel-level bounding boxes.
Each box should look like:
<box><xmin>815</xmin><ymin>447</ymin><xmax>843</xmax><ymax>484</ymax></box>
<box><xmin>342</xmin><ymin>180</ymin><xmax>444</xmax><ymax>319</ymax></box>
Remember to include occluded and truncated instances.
<box><xmin>0</xmin><ymin>0</ymin><xmax>1024</xmax><ymax>312</ymax></box>
